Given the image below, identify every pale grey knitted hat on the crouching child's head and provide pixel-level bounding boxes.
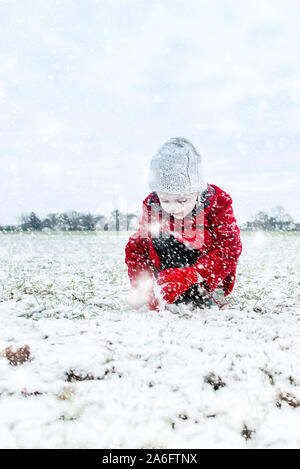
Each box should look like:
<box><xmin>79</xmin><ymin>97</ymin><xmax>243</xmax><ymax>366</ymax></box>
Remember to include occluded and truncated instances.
<box><xmin>149</xmin><ymin>137</ymin><xmax>207</xmax><ymax>194</ymax></box>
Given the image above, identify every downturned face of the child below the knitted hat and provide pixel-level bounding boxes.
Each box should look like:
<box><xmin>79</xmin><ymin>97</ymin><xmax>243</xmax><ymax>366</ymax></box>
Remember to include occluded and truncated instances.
<box><xmin>157</xmin><ymin>192</ymin><xmax>198</xmax><ymax>219</ymax></box>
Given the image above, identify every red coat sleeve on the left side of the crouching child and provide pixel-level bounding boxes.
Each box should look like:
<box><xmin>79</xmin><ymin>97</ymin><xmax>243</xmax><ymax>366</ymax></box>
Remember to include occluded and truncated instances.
<box><xmin>125</xmin><ymin>200</ymin><xmax>155</xmax><ymax>286</ymax></box>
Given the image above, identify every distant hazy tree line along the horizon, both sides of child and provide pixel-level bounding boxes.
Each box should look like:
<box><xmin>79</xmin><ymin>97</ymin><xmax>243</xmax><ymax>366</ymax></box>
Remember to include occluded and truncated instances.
<box><xmin>0</xmin><ymin>206</ymin><xmax>300</xmax><ymax>232</ymax></box>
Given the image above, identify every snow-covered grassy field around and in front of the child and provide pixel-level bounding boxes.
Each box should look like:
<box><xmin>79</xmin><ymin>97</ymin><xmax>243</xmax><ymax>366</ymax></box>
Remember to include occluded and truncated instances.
<box><xmin>0</xmin><ymin>233</ymin><xmax>300</xmax><ymax>448</ymax></box>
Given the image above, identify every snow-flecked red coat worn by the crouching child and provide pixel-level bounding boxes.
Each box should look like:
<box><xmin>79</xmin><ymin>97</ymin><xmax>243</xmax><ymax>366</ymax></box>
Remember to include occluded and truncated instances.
<box><xmin>125</xmin><ymin>184</ymin><xmax>242</xmax><ymax>296</ymax></box>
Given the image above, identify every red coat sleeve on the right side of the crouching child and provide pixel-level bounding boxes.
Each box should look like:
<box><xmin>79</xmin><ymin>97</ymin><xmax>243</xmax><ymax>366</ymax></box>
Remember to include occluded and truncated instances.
<box><xmin>195</xmin><ymin>195</ymin><xmax>242</xmax><ymax>291</ymax></box>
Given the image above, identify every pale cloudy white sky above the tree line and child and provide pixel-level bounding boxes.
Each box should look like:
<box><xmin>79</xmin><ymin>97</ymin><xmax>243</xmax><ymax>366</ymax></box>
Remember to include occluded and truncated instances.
<box><xmin>0</xmin><ymin>0</ymin><xmax>300</xmax><ymax>223</ymax></box>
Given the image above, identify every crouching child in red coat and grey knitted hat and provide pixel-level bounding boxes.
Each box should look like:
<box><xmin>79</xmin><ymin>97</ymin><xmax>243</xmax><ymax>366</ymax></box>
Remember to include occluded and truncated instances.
<box><xmin>125</xmin><ymin>137</ymin><xmax>242</xmax><ymax>310</ymax></box>
